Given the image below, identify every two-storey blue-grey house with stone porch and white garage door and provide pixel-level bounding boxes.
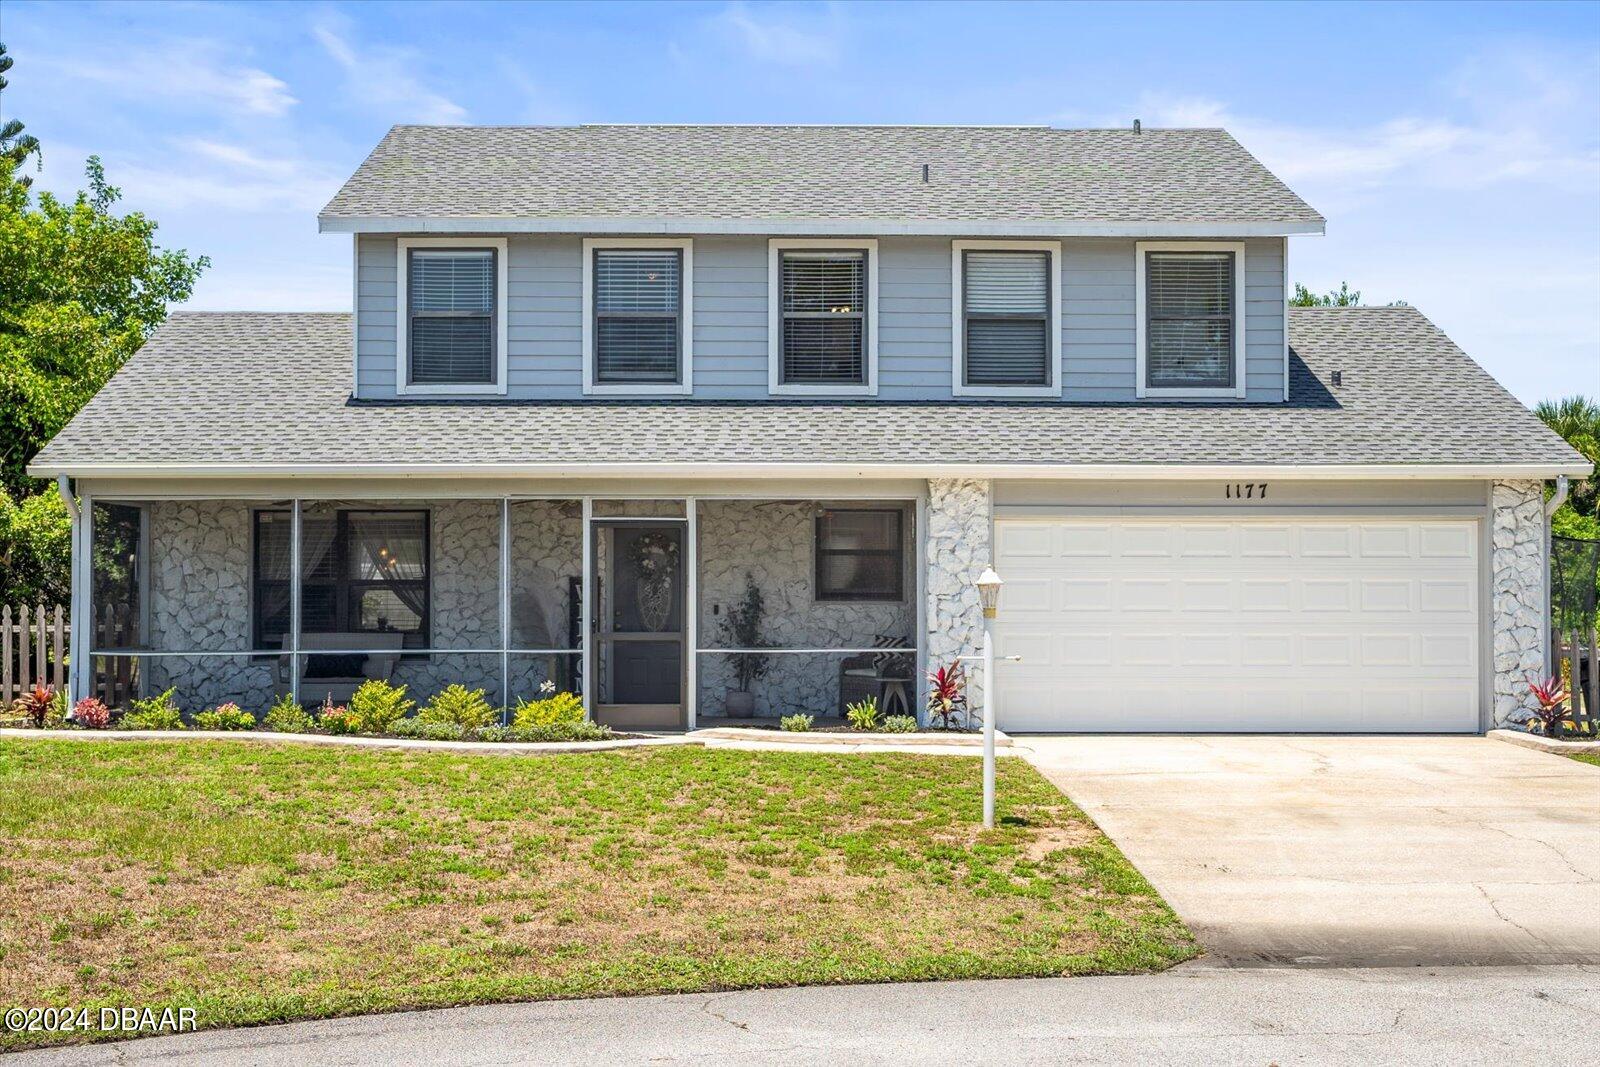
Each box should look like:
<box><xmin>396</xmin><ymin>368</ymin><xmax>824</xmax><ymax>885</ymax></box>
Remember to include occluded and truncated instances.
<box><xmin>30</xmin><ymin>126</ymin><xmax>1587</xmax><ymax>733</ymax></box>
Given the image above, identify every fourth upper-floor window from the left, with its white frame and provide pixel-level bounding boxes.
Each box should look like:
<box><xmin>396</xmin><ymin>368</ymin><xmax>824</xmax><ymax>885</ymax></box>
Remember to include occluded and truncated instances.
<box><xmin>954</xmin><ymin>242</ymin><xmax>1059</xmax><ymax>395</ymax></box>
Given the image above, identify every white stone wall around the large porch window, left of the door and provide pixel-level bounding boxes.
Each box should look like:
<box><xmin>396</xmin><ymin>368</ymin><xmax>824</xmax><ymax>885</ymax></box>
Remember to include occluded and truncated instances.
<box><xmin>146</xmin><ymin>501</ymin><xmax>582</xmax><ymax>712</ymax></box>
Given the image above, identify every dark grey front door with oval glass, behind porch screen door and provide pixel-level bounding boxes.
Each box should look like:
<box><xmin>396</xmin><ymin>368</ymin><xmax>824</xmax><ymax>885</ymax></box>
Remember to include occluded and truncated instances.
<box><xmin>594</xmin><ymin>522</ymin><xmax>685</xmax><ymax>729</ymax></box>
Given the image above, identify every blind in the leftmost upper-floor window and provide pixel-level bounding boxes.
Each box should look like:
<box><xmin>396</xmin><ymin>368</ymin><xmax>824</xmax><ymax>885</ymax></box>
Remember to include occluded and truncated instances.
<box><xmin>406</xmin><ymin>248</ymin><xmax>494</xmax><ymax>384</ymax></box>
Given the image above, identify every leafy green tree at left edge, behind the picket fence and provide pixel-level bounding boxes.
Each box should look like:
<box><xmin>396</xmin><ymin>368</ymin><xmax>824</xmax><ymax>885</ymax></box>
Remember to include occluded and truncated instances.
<box><xmin>0</xmin><ymin>46</ymin><xmax>211</xmax><ymax>601</ymax></box>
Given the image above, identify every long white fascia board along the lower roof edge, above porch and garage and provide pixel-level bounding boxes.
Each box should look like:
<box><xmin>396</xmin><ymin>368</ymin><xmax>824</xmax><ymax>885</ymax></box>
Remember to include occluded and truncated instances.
<box><xmin>27</xmin><ymin>462</ymin><xmax>1590</xmax><ymax>482</ymax></box>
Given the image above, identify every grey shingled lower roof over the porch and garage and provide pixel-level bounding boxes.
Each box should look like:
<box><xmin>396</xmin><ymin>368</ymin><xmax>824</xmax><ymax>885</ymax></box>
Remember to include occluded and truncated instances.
<box><xmin>29</xmin><ymin>307</ymin><xmax>1589</xmax><ymax>477</ymax></box>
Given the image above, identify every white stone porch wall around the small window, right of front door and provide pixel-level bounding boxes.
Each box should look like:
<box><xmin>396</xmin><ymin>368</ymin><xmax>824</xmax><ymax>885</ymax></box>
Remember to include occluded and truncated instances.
<box><xmin>696</xmin><ymin>501</ymin><xmax>917</xmax><ymax>718</ymax></box>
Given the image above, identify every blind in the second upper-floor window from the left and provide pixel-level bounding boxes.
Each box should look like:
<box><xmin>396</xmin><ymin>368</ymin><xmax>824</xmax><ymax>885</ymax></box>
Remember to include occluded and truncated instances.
<box><xmin>594</xmin><ymin>250</ymin><xmax>683</xmax><ymax>382</ymax></box>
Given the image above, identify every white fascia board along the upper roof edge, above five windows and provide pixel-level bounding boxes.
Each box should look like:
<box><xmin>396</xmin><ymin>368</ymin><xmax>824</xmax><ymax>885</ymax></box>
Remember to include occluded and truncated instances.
<box><xmin>317</xmin><ymin>216</ymin><xmax>1326</xmax><ymax>238</ymax></box>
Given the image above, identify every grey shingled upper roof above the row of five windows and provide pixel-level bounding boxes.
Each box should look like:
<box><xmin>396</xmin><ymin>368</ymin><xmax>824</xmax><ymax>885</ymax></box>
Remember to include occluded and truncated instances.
<box><xmin>318</xmin><ymin>126</ymin><xmax>1323</xmax><ymax>237</ymax></box>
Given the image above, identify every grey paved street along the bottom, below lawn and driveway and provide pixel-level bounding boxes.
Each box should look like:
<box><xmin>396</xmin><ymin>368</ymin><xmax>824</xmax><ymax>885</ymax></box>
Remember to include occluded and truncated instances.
<box><xmin>15</xmin><ymin>966</ymin><xmax>1600</xmax><ymax>1067</ymax></box>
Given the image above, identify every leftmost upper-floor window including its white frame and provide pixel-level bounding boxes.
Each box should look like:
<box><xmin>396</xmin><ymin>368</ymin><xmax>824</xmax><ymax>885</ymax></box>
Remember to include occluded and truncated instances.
<box><xmin>395</xmin><ymin>237</ymin><xmax>506</xmax><ymax>394</ymax></box>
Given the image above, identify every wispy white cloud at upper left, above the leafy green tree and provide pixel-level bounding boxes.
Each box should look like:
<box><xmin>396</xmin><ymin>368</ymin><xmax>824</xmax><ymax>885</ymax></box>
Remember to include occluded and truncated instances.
<box><xmin>49</xmin><ymin>38</ymin><xmax>298</xmax><ymax>117</ymax></box>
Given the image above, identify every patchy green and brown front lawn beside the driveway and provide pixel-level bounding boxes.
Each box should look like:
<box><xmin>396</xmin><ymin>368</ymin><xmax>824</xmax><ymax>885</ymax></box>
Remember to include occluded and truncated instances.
<box><xmin>0</xmin><ymin>741</ymin><xmax>1198</xmax><ymax>1049</ymax></box>
